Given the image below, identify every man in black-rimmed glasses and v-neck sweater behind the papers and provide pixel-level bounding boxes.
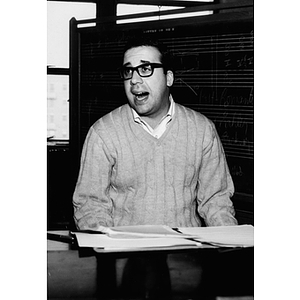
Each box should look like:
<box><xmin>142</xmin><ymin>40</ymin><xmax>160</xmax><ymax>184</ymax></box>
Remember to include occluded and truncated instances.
<box><xmin>73</xmin><ymin>36</ymin><xmax>237</xmax><ymax>299</ymax></box>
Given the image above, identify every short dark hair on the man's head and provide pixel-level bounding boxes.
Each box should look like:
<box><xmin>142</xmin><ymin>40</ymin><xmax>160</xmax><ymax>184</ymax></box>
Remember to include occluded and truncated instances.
<box><xmin>123</xmin><ymin>34</ymin><xmax>174</xmax><ymax>73</ymax></box>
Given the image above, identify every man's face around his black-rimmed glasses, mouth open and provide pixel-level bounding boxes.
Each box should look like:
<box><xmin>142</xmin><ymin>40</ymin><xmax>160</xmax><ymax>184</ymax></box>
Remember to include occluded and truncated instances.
<box><xmin>123</xmin><ymin>46</ymin><xmax>174</xmax><ymax>120</ymax></box>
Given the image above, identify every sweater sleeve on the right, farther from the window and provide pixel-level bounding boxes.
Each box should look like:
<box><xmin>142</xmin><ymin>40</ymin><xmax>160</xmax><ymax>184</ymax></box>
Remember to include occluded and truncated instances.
<box><xmin>198</xmin><ymin>122</ymin><xmax>237</xmax><ymax>226</ymax></box>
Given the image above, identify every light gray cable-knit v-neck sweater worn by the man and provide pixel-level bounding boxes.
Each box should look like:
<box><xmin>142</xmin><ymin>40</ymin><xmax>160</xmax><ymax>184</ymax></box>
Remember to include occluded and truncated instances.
<box><xmin>73</xmin><ymin>103</ymin><xmax>237</xmax><ymax>229</ymax></box>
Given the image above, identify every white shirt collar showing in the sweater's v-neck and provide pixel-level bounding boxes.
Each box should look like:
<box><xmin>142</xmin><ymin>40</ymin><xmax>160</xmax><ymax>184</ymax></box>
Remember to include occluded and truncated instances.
<box><xmin>131</xmin><ymin>94</ymin><xmax>175</xmax><ymax>139</ymax></box>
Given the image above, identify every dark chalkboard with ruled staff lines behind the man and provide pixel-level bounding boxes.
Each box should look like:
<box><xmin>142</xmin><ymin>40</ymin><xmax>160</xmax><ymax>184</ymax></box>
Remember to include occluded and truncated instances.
<box><xmin>70</xmin><ymin>14</ymin><xmax>254</xmax><ymax>218</ymax></box>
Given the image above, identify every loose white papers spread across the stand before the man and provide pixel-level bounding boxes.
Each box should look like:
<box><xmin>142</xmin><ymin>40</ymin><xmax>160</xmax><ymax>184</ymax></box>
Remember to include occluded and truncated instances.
<box><xmin>75</xmin><ymin>225</ymin><xmax>254</xmax><ymax>251</ymax></box>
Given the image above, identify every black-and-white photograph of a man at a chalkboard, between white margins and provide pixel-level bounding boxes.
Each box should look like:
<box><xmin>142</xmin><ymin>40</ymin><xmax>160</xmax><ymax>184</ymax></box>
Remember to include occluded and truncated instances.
<box><xmin>47</xmin><ymin>0</ymin><xmax>255</xmax><ymax>300</ymax></box>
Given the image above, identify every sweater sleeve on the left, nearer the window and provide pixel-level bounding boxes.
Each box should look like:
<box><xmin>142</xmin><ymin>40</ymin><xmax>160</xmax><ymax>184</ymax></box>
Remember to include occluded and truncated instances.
<box><xmin>73</xmin><ymin>127</ymin><xmax>113</xmax><ymax>229</ymax></box>
